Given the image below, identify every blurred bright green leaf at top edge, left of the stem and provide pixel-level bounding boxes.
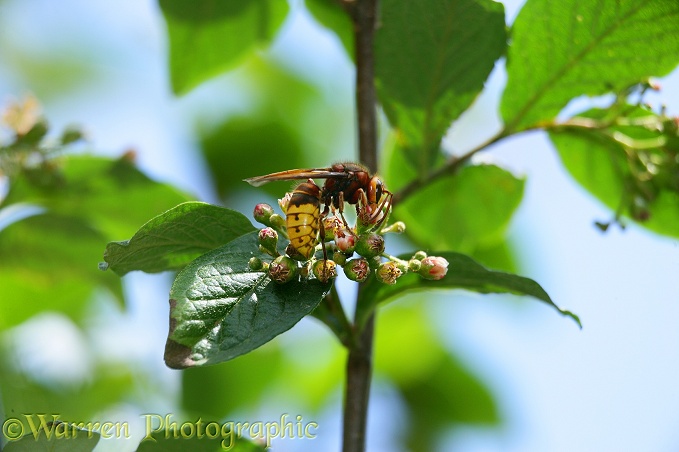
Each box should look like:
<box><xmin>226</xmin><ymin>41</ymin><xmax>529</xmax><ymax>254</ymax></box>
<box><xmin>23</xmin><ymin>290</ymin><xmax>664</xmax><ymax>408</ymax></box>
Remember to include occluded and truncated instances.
<box><xmin>159</xmin><ymin>0</ymin><xmax>288</xmax><ymax>94</ymax></box>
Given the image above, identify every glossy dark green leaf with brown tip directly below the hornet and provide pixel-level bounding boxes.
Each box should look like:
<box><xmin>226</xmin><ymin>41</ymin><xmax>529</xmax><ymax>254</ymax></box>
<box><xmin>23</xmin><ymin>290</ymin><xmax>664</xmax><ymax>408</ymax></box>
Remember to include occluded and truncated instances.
<box><xmin>165</xmin><ymin>233</ymin><xmax>331</xmax><ymax>368</ymax></box>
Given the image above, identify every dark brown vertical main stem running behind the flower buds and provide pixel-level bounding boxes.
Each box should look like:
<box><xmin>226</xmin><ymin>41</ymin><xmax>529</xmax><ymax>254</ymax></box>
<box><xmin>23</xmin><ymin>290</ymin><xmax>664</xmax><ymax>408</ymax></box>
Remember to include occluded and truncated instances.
<box><xmin>342</xmin><ymin>0</ymin><xmax>378</xmax><ymax>452</ymax></box>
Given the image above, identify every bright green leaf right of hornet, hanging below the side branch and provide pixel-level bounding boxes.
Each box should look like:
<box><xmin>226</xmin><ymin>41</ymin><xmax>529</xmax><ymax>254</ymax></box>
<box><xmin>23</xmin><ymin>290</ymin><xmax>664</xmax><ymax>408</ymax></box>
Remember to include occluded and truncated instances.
<box><xmin>394</xmin><ymin>165</ymin><xmax>524</xmax><ymax>253</ymax></box>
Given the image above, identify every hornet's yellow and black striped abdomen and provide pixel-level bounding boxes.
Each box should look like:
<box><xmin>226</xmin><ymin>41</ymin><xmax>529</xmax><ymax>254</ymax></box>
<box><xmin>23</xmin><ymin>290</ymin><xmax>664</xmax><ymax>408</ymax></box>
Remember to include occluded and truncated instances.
<box><xmin>285</xmin><ymin>182</ymin><xmax>321</xmax><ymax>259</ymax></box>
